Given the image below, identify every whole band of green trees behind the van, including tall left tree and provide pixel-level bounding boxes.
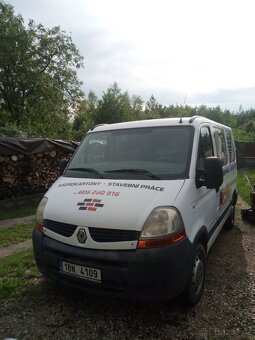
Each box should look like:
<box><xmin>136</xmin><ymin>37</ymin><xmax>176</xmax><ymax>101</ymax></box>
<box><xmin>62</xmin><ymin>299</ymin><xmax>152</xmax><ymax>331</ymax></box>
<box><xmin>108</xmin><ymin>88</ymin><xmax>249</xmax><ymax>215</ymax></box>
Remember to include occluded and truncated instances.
<box><xmin>0</xmin><ymin>0</ymin><xmax>255</xmax><ymax>141</ymax></box>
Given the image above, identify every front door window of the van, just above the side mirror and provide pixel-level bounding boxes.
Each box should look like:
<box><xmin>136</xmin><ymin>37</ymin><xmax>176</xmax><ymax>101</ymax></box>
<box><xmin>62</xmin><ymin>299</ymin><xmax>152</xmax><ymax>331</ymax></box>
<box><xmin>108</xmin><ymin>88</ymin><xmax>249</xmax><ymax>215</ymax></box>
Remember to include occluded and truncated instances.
<box><xmin>198</xmin><ymin>126</ymin><xmax>214</xmax><ymax>168</ymax></box>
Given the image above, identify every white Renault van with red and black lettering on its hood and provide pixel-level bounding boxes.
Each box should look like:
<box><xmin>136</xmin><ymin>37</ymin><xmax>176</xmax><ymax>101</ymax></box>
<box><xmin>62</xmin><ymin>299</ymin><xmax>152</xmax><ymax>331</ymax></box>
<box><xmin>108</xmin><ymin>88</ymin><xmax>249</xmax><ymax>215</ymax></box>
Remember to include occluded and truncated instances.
<box><xmin>33</xmin><ymin>116</ymin><xmax>238</xmax><ymax>304</ymax></box>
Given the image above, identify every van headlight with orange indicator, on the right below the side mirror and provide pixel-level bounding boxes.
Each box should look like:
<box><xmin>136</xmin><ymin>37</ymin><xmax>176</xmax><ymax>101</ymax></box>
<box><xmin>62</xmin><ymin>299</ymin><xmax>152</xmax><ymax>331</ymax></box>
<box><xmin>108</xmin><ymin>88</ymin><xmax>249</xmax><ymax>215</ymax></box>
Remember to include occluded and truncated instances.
<box><xmin>137</xmin><ymin>207</ymin><xmax>185</xmax><ymax>248</ymax></box>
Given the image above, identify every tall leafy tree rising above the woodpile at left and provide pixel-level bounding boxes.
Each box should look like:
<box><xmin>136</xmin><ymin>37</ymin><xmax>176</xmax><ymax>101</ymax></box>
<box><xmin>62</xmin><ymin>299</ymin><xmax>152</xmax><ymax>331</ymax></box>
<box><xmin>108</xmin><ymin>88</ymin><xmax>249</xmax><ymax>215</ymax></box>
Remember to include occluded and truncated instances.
<box><xmin>0</xmin><ymin>1</ymin><xmax>83</xmax><ymax>138</ymax></box>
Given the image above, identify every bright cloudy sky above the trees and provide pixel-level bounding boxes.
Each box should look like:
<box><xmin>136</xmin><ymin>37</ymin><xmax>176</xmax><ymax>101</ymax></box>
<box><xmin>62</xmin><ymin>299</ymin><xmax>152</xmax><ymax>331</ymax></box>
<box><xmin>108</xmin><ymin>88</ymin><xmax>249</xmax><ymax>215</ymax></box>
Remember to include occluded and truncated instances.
<box><xmin>5</xmin><ymin>0</ymin><xmax>255</xmax><ymax>112</ymax></box>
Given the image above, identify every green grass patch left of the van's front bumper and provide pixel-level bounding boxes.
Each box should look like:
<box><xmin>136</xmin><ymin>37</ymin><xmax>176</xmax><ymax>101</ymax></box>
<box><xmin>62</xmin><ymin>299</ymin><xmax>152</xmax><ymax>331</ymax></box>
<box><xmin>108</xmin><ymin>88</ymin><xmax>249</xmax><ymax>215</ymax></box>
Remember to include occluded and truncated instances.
<box><xmin>0</xmin><ymin>249</ymin><xmax>41</xmax><ymax>301</ymax></box>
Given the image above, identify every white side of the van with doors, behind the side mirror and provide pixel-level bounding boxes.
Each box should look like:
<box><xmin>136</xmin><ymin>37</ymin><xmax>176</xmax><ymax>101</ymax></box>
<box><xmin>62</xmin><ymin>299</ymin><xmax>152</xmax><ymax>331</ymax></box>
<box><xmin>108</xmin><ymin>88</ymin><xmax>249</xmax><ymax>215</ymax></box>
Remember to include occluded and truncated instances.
<box><xmin>174</xmin><ymin>123</ymin><xmax>237</xmax><ymax>250</ymax></box>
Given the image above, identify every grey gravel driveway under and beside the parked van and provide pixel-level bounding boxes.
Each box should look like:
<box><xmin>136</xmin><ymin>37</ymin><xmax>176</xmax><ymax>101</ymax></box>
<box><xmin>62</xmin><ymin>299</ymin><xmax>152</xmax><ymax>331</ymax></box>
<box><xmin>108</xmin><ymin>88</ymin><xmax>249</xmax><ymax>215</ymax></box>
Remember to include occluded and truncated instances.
<box><xmin>0</xmin><ymin>202</ymin><xmax>255</xmax><ymax>340</ymax></box>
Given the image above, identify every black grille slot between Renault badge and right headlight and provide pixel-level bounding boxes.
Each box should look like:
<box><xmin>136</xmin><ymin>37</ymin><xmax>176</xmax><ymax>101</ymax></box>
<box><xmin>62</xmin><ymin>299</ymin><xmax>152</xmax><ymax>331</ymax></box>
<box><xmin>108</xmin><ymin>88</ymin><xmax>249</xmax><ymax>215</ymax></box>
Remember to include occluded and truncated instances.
<box><xmin>89</xmin><ymin>227</ymin><xmax>140</xmax><ymax>242</ymax></box>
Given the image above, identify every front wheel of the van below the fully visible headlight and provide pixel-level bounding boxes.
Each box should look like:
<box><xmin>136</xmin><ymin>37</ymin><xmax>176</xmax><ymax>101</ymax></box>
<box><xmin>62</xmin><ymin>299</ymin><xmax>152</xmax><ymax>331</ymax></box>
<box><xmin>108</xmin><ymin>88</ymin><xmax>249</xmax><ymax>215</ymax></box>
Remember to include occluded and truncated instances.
<box><xmin>183</xmin><ymin>243</ymin><xmax>206</xmax><ymax>306</ymax></box>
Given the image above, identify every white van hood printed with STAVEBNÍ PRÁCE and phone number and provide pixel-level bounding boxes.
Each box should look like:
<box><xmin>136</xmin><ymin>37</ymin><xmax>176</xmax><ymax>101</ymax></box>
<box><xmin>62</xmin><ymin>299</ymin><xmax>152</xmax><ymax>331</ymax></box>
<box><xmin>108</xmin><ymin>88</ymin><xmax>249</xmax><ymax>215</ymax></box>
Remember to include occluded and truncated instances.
<box><xmin>44</xmin><ymin>177</ymin><xmax>184</xmax><ymax>231</ymax></box>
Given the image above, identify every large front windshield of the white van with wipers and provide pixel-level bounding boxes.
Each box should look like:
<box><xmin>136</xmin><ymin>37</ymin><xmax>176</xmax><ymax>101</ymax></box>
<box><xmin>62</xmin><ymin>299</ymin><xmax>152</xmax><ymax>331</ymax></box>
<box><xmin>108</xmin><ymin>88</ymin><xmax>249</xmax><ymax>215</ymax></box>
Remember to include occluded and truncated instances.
<box><xmin>64</xmin><ymin>126</ymin><xmax>193</xmax><ymax>180</ymax></box>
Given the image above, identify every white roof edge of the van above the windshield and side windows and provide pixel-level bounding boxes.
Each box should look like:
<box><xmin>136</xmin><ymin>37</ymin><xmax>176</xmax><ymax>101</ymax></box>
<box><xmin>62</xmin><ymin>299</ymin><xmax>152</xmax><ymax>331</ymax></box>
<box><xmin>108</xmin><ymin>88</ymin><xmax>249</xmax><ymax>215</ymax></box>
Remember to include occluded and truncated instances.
<box><xmin>89</xmin><ymin>116</ymin><xmax>230</xmax><ymax>132</ymax></box>
